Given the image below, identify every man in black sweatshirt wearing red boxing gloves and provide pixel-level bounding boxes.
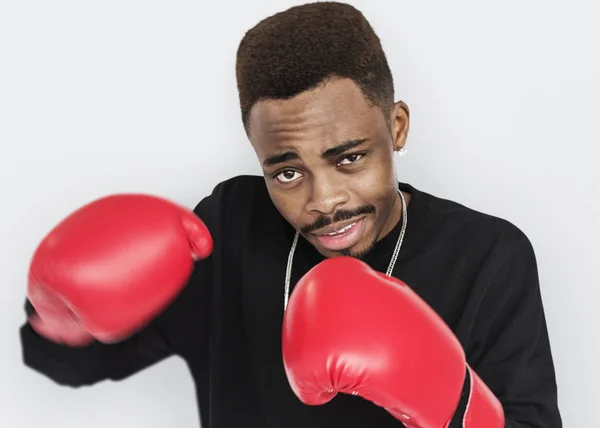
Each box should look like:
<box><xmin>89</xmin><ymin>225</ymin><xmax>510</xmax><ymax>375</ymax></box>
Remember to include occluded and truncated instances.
<box><xmin>21</xmin><ymin>3</ymin><xmax>562</xmax><ymax>428</ymax></box>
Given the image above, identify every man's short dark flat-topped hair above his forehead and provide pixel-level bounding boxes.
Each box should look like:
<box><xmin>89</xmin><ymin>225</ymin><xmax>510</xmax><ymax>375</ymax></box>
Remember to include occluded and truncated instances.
<box><xmin>236</xmin><ymin>2</ymin><xmax>394</xmax><ymax>130</ymax></box>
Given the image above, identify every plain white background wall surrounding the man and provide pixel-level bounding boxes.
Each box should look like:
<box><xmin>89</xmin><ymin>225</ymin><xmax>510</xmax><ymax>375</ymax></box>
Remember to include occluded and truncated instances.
<box><xmin>0</xmin><ymin>0</ymin><xmax>600</xmax><ymax>428</ymax></box>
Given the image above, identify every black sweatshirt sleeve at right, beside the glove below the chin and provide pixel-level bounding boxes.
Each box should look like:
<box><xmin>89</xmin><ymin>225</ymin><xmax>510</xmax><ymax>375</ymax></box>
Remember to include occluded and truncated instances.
<box><xmin>468</xmin><ymin>237</ymin><xmax>562</xmax><ymax>428</ymax></box>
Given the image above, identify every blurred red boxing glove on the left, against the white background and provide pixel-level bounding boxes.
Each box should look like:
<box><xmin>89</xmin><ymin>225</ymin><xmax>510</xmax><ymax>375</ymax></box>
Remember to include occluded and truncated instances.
<box><xmin>27</xmin><ymin>194</ymin><xmax>212</xmax><ymax>346</ymax></box>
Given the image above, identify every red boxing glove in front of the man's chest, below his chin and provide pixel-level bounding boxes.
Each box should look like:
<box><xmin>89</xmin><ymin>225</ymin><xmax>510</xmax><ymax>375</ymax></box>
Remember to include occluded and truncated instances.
<box><xmin>282</xmin><ymin>257</ymin><xmax>504</xmax><ymax>428</ymax></box>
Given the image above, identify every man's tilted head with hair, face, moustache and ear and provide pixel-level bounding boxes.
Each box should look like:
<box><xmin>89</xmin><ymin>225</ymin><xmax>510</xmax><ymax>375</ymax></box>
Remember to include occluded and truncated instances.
<box><xmin>236</xmin><ymin>3</ymin><xmax>408</xmax><ymax>257</ymax></box>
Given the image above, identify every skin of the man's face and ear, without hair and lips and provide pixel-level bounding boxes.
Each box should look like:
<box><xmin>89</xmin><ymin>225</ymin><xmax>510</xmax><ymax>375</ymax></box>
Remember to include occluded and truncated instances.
<box><xmin>248</xmin><ymin>78</ymin><xmax>410</xmax><ymax>258</ymax></box>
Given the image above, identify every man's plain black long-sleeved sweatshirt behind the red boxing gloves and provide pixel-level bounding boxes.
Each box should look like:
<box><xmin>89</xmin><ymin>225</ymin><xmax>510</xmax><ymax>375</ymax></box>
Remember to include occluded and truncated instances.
<box><xmin>21</xmin><ymin>176</ymin><xmax>562</xmax><ymax>428</ymax></box>
